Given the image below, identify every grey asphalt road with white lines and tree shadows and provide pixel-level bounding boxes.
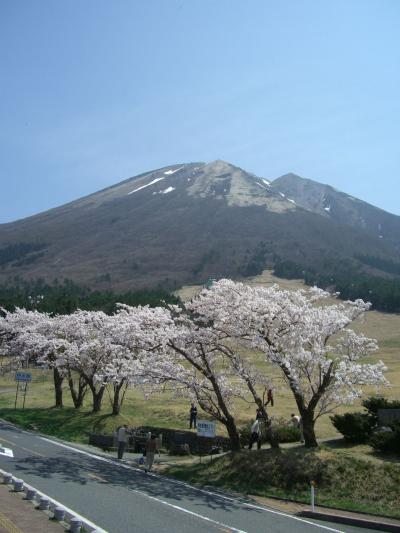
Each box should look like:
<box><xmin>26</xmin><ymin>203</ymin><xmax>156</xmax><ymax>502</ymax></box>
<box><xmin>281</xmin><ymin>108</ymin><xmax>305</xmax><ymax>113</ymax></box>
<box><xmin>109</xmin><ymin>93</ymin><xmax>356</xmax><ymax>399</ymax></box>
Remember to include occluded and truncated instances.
<box><xmin>0</xmin><ymin>421</ymin><xmax>378</xmax><ymax>533</ymax></box>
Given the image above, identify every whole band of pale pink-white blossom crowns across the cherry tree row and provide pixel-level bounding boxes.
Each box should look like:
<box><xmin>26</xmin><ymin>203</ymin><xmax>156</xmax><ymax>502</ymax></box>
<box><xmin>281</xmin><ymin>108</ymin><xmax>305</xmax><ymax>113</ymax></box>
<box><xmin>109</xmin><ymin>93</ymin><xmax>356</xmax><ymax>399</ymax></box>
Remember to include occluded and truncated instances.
<box><xmin>0</xmin><ymin>279</ymin><xmax>388</xmax><ymax>442</ymax></box>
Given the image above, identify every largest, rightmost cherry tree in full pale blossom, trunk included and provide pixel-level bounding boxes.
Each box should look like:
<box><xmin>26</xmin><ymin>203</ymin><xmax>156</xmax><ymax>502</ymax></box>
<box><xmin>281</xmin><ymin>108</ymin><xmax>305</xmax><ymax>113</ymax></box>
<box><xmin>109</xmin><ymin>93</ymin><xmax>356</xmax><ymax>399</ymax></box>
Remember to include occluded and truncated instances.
<box><xmin>189</xmin><ymin>280</ymin><xmax>387</xmax><ymax>447</ymax></box>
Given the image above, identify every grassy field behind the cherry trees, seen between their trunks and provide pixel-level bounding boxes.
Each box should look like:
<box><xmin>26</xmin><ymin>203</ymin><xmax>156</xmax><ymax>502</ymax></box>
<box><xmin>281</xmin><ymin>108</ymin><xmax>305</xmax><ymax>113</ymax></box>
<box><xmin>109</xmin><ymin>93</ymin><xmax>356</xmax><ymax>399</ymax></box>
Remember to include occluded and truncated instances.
<box><xmin>0</xmin><ymin>271</ymin><xmax>400</xmax><ymax>441</ymax></box>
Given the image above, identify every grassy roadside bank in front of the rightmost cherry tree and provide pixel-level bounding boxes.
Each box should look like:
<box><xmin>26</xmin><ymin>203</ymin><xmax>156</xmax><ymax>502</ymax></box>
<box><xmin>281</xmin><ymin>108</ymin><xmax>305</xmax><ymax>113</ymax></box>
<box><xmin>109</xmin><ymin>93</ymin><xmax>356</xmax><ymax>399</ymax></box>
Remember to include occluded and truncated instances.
<box><xmin>166</xmin><ymin>447</ymin><xmax>400</xmax><ymax>519</ymax></box>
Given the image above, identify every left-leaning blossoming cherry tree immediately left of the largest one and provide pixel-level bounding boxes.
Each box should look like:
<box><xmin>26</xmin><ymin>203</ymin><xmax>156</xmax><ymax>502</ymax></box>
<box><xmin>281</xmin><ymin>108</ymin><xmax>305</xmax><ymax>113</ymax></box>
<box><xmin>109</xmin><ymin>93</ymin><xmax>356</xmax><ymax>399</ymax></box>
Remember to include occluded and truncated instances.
<box><xmin>129</xmin><ymin>306</ymin><xmax>253</xmax><ymax>450</ymax></box>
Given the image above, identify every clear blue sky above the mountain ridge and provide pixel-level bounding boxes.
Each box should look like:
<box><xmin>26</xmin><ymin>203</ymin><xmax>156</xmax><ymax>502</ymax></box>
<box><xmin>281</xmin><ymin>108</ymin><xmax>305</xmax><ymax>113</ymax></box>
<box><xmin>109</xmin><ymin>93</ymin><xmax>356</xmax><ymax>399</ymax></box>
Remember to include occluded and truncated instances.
<box><xmin>0</xmin><ymin>0</ymin><xmax>400</xmax><ymax>222</ymax></box>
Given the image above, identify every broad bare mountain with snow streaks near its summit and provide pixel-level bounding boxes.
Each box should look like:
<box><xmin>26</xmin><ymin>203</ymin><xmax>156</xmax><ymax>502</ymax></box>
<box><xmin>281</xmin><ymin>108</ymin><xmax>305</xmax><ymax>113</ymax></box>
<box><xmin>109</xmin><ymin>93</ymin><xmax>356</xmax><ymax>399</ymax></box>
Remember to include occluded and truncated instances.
<box><xmin>0</xmin><ymin>161</ymin><xmax>400</xmax><ymax>298</ymax></box>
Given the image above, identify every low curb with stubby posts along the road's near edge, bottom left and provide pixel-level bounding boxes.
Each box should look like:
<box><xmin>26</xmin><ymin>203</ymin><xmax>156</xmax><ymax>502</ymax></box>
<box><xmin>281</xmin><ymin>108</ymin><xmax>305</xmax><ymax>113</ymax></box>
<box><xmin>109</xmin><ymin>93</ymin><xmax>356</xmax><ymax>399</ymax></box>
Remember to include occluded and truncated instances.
<box><xmin>0</xmin><ymin>469</ymin><xmax>108</xmax><ymax>533</ymax></box>
